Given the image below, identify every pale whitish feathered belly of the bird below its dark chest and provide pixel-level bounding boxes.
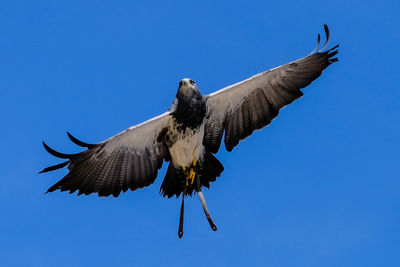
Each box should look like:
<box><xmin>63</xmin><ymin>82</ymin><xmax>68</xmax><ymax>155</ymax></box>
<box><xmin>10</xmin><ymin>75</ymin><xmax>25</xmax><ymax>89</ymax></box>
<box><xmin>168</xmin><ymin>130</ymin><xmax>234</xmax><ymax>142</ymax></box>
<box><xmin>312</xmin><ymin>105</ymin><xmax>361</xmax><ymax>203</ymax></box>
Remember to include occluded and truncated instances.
<box><xmin>169</xmin><ymin>125</ymin><xmax>204</xmax><ymax>167</ymax></box>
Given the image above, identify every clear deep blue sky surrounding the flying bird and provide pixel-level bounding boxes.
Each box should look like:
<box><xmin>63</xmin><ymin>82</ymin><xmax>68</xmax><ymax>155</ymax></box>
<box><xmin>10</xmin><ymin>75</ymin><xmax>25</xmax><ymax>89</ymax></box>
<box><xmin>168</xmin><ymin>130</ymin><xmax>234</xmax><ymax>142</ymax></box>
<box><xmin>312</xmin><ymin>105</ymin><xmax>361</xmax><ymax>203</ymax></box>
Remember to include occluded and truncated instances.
<box><xmin>0</xmin><ymin>0</ymin><xmax>400</xmax><ymax>267</ymax></box>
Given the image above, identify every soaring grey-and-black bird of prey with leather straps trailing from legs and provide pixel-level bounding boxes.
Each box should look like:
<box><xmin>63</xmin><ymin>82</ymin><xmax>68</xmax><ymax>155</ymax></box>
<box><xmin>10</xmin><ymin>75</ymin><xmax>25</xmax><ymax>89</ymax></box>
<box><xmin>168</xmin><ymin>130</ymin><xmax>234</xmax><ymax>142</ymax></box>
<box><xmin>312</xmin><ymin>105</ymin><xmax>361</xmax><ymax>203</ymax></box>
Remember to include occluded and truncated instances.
<box><xmin>41</xmin><ymin>25</ymin><xmax>338</xmax><ymax>238</ymax></box>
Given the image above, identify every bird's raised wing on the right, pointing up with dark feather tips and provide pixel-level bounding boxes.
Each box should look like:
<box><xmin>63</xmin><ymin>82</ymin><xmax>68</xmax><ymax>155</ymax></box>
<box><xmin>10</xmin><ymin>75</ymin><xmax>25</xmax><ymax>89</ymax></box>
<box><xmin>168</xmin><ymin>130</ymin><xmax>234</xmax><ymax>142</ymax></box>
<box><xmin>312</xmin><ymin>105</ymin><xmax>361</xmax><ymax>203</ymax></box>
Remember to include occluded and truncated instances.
<box><xmin>203</xmin><ymin>25</ymin><xmax>338</xmax><ymax>153</ymax></box>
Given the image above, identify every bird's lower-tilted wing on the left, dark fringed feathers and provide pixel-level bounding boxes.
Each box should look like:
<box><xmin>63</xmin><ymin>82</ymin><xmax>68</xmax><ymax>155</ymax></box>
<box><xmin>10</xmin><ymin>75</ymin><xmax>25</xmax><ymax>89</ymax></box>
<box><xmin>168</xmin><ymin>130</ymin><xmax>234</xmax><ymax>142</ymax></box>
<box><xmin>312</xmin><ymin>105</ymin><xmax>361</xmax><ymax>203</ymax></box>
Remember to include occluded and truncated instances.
<box><xmin>41</xmin><ymin>112</ymin><xmax>171</xmax><ymax>197</ymax></box>
